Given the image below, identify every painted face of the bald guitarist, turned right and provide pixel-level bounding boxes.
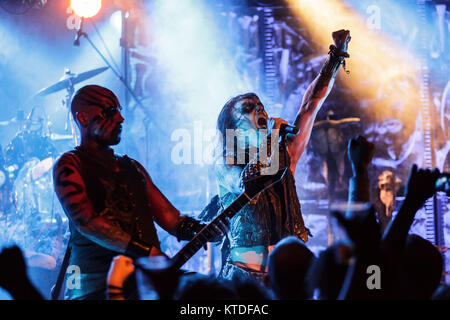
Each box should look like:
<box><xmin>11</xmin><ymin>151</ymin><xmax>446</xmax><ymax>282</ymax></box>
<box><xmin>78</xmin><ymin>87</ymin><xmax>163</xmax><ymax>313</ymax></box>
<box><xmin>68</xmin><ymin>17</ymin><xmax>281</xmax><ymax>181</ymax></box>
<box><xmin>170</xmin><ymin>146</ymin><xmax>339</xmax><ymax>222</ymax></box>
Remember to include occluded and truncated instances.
<box><xmin>87</xmin><ymin>98</ymin><xmax>124</xmax><ymax>146</ymax></box>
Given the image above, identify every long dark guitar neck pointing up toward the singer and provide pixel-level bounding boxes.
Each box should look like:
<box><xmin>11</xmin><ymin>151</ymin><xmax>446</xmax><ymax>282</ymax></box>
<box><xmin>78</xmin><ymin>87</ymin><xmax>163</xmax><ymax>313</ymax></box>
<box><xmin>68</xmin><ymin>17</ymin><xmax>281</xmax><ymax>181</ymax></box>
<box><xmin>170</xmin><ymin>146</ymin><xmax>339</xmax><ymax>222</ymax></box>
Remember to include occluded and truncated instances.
<box><xmin>172</xmin><ymin>193</ymin><xmax>249</xmax><ymax>268</ymax></box>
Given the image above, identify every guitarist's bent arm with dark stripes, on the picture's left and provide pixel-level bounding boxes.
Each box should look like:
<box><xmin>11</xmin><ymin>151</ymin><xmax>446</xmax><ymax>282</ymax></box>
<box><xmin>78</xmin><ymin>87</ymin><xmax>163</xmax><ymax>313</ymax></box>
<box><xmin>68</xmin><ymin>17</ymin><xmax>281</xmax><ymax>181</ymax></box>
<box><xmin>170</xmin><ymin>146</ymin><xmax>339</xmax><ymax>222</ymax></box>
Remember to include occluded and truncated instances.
<box><xmin>53</xmin><ymin>153</ymin><xmax>131</xmax><ymax>253</ymax></box>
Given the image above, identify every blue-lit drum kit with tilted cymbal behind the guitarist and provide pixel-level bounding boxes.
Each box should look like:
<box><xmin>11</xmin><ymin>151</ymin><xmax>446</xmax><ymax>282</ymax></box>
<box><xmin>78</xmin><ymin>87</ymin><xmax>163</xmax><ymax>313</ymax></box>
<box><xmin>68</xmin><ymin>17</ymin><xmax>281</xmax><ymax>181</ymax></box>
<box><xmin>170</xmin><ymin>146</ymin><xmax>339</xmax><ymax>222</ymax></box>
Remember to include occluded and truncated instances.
<box><xmin>0</xmin><ymin>67</ymin><xmax>108</xmax><ymax>269</ymax></box>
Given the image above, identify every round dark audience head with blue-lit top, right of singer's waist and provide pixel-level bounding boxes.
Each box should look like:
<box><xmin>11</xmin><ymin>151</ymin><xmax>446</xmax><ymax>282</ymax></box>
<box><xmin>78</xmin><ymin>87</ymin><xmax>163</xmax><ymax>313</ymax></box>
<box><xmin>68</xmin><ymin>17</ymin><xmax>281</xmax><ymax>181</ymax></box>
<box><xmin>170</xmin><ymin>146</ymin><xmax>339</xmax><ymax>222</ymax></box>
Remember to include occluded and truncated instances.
<box><xmin>267</xmin><ymin>236</ymin><xmax>315</xmax><ymax>300</ymax></box>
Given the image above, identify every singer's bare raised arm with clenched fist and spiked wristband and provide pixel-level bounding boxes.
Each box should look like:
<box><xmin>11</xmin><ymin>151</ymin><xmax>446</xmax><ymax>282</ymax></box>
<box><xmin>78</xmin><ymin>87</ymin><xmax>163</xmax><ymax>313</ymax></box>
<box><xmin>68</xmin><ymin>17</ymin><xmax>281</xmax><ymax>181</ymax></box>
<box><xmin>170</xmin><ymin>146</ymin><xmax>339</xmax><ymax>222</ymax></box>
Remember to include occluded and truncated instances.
<box><xmin>288</xmin><ymin>30</ymin><xmax>350</xmax><ymax>172</ymax></box>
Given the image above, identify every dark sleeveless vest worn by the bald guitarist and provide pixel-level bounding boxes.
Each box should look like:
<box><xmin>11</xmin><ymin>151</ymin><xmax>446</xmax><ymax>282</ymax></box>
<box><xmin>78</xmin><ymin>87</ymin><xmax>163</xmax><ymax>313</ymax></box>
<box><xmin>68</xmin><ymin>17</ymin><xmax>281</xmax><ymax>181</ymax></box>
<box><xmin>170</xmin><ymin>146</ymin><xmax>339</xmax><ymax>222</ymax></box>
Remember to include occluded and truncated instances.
<box><xmin>69</xmin><ymin>148</ymin><xmax>160</xmax><ymax>273</ymax></box>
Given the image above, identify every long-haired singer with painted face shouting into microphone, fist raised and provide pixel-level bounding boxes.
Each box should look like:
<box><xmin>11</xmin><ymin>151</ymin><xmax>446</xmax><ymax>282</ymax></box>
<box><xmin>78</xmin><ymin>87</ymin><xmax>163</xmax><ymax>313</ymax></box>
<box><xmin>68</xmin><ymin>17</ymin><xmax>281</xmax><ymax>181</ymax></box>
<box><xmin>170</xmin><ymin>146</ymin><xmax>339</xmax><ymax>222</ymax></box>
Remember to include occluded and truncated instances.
<box><xmin>215</xmin><ymin>30</ymin><xmax>350</xmax><ymax>281</ymax></box>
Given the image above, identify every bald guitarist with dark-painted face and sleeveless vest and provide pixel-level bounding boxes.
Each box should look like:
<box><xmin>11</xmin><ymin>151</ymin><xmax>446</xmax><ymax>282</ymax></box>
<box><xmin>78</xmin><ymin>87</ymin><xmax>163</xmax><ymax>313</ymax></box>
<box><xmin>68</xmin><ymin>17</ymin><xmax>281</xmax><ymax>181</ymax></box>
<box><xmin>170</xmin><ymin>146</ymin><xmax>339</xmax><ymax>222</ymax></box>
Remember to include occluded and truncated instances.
<box><xmin>53</xmin><ymin>85</ymin><xmax>226</xmax><ymax>300</ymax></box>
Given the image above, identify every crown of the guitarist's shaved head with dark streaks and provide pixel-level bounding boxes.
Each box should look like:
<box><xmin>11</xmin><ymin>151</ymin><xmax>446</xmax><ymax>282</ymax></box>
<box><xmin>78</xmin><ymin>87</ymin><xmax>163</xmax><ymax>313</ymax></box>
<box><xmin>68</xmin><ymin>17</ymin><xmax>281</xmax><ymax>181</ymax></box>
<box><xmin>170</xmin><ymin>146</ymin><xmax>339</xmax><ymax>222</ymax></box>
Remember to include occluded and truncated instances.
<box><xmin>70</xmin><ymin>85</ymin><xmax>119</xmax><ymax>119</ymax></box>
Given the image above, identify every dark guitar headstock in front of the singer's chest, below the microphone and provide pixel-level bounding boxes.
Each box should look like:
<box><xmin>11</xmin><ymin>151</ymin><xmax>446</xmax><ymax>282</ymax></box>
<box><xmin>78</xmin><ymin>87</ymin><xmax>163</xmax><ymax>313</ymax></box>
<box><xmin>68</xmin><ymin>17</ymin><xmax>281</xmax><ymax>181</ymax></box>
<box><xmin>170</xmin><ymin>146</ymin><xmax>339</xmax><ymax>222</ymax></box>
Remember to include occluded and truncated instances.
<box><xmin>241</xmin><ymin>161</ymin><xmax>289</xmax><ymax>198</ymax></box>
